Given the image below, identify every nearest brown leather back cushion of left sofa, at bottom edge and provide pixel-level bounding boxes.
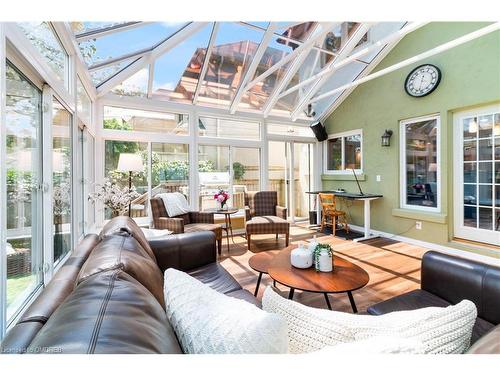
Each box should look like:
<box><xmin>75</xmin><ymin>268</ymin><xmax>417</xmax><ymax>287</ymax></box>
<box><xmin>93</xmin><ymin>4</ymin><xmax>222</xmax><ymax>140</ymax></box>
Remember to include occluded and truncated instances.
<box><xmin>28</xmin><ymin>270</ymin><xmax>181</xmax><ymax>354</ymax></box>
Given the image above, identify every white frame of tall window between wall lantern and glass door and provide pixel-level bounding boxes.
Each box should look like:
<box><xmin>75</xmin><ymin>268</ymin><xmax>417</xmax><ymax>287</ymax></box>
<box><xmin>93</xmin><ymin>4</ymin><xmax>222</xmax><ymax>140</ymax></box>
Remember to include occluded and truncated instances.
<box><xmin>399</xmin><ymin>113</ymin><xmax>442</xmax><ymax>213</ymax></box>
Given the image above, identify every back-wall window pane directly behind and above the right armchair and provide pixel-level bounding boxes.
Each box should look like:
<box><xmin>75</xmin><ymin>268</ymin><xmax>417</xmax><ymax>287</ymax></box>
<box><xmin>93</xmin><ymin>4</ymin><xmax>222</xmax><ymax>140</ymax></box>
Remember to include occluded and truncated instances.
<box><xmin>232</xmin><ymin>147</ymin><xmax>260</xmax><ymax>209</ymax></box>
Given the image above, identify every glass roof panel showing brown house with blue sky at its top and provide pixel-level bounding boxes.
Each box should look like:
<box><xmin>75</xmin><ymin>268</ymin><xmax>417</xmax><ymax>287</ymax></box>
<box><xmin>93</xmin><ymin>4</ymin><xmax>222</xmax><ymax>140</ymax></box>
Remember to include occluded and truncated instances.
<box><xmin>198</xmin><ymin>23</ymin><xmax>264</xmax><ymax>108</ymax></box>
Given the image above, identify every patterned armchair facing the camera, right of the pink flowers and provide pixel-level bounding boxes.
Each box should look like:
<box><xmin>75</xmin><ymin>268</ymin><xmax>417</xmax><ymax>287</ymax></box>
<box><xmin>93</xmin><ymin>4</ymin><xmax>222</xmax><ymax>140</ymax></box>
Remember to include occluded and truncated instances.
<box><xmin>245</xmin><ymin>191</ymin><xmax>290</xmax><ymax>250</ymax></box>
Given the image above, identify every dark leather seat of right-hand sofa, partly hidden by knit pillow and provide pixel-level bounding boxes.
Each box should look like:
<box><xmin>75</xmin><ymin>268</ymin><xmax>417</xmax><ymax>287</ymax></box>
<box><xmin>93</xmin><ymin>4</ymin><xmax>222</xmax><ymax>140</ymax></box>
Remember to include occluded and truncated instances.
<box><xmin>367</xmin><ymin>289</ymin><xmax>493</xmax><ymax>343</ymax></box>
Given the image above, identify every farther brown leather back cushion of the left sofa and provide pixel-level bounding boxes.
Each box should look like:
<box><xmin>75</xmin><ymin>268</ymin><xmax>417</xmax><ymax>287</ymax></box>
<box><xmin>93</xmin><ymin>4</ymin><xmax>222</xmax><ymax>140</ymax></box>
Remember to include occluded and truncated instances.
<box><xmin>77</xmin><ymin>231</ymin><xmax>164</xmax><ymax>306</ymax></box>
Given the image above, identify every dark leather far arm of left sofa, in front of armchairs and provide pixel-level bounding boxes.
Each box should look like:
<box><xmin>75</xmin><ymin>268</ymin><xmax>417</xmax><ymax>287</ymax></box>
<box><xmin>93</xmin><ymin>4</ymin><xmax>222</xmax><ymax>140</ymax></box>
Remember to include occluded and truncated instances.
<box><xmin>149</xmin><ymin>231</ymin><xmax>217</xmax><ymax>272</ymax></box>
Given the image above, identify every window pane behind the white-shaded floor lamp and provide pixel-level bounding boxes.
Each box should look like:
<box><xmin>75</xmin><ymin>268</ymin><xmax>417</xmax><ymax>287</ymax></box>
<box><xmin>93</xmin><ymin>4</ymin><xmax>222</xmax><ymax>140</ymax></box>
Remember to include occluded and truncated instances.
<box><xmin>104</xmin><ymin>140</ymin><xmax>149</xmax><ymax>219</ymax></box>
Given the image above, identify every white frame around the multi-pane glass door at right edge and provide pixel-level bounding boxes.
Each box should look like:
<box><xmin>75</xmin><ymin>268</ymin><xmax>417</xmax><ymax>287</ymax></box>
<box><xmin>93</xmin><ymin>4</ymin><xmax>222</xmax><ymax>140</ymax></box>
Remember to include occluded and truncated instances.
<box><xmin>453</xmin><ymin>103</ymin><xmax>500</xmax><ymax>245</ymax></box>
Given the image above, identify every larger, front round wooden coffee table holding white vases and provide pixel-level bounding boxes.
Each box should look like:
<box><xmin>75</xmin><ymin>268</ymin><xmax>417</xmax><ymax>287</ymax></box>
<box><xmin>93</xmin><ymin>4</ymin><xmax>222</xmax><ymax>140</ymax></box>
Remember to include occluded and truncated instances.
<box><xmin>267</xmin><ymin>246</ymin><xmax>370</xmax><ymax>313</ymax></box>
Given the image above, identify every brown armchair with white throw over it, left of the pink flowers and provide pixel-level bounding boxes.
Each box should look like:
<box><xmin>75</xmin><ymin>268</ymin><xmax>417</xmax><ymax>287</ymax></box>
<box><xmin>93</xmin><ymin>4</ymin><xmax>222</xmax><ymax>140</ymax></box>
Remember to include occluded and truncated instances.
<box><xmin>150</xmin><ymin>197</ymin><xmax>222</xmax><ymax>254</ymax></box>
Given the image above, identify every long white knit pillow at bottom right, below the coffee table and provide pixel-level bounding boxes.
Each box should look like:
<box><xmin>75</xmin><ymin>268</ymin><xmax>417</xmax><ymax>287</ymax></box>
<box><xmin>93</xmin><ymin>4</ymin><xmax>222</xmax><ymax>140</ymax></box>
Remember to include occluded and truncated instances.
<box><xmin>262</xmin><ymin>287</ymin><xmax>477</xmax><ymax>354</ymax></box>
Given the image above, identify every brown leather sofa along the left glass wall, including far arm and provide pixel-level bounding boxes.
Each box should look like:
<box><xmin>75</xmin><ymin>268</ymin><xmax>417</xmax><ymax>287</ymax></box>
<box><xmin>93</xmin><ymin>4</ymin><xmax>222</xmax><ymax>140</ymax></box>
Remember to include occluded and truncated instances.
<box><xmin>1</xmin><ymin>217</ymin><xmax>259</xmax><ymax>354</ymax></box>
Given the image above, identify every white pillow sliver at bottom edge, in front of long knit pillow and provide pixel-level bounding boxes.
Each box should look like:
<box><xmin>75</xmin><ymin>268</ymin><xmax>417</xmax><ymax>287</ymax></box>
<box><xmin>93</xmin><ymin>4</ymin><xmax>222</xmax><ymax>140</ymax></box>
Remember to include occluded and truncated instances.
<box><xmin>312</xmin><ymin>336</ymin><xmax>425</xmax><ymax>355</ymax></box>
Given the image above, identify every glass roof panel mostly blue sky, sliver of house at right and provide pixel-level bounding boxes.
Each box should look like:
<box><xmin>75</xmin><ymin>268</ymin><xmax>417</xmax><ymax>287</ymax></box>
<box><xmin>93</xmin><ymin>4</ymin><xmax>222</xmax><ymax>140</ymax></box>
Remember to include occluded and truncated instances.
<box><xmin>152</xmin><ymin>24</ymin><xmax>213</xmax><ymax>102</ymax></box>
